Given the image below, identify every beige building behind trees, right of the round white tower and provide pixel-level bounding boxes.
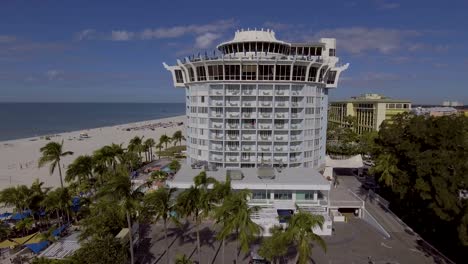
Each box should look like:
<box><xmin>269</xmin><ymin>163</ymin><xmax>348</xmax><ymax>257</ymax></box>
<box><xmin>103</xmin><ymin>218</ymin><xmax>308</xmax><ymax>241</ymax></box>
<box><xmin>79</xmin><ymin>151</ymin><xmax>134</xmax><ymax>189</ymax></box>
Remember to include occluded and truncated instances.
<box><xmin>328</xmin><ymin>94</ymin><xmax>411</xmax><ymax>134</ymax></box>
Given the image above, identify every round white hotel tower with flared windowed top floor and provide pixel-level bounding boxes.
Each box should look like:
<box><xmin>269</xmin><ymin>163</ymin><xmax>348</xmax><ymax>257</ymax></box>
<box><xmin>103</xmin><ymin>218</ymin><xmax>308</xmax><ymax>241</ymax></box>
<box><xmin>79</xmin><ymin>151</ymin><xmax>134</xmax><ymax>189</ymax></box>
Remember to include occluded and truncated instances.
<box><xmin>164</xmin><ymin>30</ymin><xmax>348</xmax><ymax>235</ymax></box>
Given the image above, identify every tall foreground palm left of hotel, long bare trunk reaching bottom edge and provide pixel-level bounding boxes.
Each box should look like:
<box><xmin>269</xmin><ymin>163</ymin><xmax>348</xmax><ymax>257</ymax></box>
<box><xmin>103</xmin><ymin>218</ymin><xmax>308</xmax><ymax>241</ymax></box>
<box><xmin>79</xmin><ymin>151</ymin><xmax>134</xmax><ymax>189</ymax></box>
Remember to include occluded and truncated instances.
<box><xmin>99</xmin><ymin>167</ymin><xmax>143</xmax><ymax>264</ymax></box>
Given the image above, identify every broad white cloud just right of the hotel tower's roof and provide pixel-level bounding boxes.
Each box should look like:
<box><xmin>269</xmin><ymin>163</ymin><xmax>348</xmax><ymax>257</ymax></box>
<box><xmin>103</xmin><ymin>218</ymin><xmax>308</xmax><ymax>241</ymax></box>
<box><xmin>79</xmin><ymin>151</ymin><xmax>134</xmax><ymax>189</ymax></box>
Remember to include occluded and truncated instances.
<box><xmin>314</xmin><ymin>27</ymin><xmax>421</xmax><ymax>54</ymax></box>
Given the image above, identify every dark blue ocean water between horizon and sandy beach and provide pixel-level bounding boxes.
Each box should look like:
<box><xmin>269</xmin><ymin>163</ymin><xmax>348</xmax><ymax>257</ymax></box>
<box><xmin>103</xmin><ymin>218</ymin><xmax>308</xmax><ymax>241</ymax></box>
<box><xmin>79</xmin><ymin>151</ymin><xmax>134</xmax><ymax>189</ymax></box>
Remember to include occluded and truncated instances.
<box><xmin>0</xmin><ymin>103</ymin><xmax>185</xmax><ymax>141</ymax></box>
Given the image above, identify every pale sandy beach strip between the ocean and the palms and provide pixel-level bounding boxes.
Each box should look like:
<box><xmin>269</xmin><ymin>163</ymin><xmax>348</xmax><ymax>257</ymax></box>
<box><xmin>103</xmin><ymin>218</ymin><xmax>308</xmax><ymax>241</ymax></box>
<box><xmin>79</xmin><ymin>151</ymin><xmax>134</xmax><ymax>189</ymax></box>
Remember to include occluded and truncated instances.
<box><xmin>0</xmin><ymin>116</ymin><xmax>186</xmax><ymax>190</ymax></box>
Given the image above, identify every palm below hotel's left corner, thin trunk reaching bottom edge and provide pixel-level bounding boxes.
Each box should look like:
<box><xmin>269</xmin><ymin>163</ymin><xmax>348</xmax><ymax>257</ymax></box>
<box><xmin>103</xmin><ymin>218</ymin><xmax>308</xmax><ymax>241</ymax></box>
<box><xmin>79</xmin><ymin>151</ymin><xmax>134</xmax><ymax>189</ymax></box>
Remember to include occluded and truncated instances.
<box><xmin>143</xmin><ymin>187</ymin><xmax>178</xmax><ymax>264</ymax></box>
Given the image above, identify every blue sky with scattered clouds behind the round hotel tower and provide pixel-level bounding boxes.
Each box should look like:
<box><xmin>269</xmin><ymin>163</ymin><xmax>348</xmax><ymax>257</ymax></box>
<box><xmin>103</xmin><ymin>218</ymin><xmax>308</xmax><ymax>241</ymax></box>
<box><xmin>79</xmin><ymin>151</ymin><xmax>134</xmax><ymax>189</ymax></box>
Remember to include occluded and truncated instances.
<box><xmin>0</xmin><ymin>0</ymin><xmax>468</xmax><ymax>104</ymax></box>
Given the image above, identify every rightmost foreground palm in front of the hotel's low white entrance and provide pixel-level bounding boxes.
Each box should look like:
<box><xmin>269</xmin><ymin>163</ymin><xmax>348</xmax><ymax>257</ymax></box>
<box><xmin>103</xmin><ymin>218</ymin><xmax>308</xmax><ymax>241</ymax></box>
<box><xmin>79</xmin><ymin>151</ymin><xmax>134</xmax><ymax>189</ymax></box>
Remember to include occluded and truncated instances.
<box><xmin>286</xmin><ymin>210</ymin><xmax>327</xmax><ymax>264</ymax></box>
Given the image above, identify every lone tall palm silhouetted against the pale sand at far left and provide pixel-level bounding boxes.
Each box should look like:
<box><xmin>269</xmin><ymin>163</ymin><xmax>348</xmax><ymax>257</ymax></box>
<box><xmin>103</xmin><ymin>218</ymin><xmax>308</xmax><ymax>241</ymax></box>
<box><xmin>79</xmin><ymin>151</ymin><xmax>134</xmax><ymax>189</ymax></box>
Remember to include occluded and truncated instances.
<box><xmin>39</xmin><ymin>140</ymin><xmax>73</xmax><ymax>188</ymax></box>
